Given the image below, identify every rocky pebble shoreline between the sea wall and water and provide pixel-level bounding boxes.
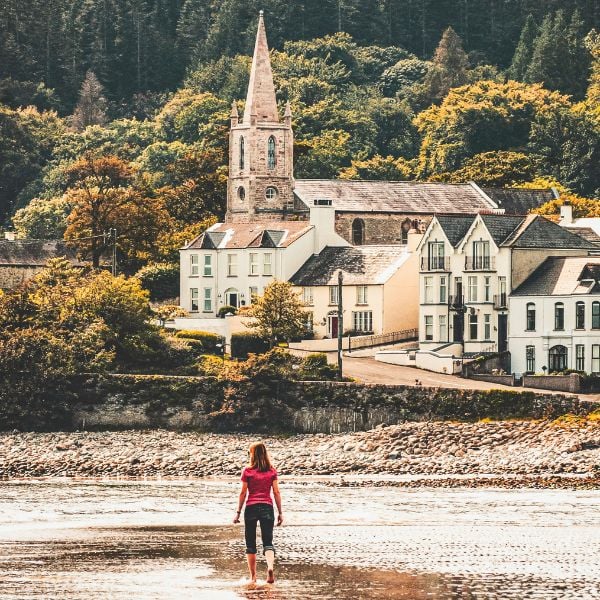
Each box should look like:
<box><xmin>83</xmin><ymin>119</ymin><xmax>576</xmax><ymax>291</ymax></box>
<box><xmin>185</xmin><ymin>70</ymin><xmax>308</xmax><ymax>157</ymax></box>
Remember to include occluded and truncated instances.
<box><xmin>0</xmin><ymin>419</ymin><xmax>600</xmax><ymax>489</ymax></box>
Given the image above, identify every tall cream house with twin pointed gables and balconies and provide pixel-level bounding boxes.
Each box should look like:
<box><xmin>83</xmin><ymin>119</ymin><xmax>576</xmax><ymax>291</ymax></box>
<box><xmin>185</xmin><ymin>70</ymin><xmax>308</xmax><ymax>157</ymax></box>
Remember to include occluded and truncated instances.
<box><xmin>384</xmin><ymin>214</ymin><xmax>594</xmax><ymax>371</ymax></box>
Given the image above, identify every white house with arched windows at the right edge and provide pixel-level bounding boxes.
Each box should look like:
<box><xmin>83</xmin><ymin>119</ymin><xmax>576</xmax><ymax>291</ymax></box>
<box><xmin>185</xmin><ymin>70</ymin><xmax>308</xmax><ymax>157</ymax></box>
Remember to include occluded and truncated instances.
<box><xmin>509</xmin><ymin>256</ymin><xmax>600</xmax><ymax>374</ymax></box>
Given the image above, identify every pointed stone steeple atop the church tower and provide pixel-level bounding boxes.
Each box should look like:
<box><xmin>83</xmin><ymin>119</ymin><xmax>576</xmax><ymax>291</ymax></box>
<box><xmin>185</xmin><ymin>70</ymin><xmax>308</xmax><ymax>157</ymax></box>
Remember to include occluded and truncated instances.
<box><xmin>243</xmin><ymin>10</ymin><xmax>279</xmax><ymax>125</ymax></box>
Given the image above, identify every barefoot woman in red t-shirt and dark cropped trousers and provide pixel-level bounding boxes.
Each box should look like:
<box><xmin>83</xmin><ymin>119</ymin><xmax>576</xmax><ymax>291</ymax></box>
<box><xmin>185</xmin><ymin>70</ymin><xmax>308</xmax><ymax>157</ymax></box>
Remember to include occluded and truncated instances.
<box><xmin>233</xmin><ymin>442</ymin><xmax>283</xmax><ymax>583</ymax></box>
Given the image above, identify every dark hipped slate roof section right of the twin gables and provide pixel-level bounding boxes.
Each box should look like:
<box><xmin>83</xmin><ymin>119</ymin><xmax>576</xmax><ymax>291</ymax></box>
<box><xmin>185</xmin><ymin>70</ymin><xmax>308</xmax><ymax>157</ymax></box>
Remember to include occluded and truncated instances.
<box><xmin>502</xmin><ymin>215</ymin><xmax>596</xmax><ymax>250</ymax></box>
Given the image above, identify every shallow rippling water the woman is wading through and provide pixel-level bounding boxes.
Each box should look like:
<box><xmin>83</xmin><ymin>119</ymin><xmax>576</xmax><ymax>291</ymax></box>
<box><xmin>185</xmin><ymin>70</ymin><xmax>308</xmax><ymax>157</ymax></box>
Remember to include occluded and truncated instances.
<box><xmin>0</xmin><ymin>480</ymin><xmax>600</xmax><ymax>600</ymax></box>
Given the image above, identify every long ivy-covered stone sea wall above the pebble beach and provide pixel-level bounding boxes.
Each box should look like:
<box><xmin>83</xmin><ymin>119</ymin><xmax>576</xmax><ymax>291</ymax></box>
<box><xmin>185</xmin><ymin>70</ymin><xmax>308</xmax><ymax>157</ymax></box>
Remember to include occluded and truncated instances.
<box><xmin>66</xmin><ymin>375</ymin><xmax>600</xmax><ymax>433</ymax></box>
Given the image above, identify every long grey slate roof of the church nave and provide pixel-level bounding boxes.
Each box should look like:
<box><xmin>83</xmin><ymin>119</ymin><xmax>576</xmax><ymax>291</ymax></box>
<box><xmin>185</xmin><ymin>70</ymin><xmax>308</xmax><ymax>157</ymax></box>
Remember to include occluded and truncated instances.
<box><xmin>294</xmin><ymin>179</ymin><xmax>496</xmax><ymax>214</ymax></box>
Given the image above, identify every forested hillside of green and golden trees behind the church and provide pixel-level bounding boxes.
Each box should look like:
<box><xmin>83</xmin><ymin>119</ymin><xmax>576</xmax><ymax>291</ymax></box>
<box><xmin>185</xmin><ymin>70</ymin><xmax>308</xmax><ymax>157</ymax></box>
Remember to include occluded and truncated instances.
<box><xmin>0</xmin><ymin>0</ymin><xmax>600</xmax><ymax>279</ymax></box>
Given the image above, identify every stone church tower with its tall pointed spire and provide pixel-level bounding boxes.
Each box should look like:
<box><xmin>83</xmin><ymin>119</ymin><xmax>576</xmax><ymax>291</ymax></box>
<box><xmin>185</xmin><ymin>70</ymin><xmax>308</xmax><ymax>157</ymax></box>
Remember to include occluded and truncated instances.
<box><xmin>225</xmin><ymin>11</ymin><xmax>294</xmax><ymax>223</ymax></box>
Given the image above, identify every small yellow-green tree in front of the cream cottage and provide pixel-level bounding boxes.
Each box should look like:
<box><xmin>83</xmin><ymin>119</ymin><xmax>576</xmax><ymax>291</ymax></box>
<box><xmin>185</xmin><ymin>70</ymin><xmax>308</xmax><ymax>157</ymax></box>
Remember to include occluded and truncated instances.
<box><xmin>249</xmin><ymin>281</ymin><xmax>306</xmax><ymax>348</ymax></box>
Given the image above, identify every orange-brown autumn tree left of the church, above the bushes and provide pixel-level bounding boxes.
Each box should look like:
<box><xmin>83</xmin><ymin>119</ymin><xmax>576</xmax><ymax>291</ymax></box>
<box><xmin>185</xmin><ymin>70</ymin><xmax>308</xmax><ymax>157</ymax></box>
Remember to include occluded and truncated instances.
<box><xmin>65</xmin><ymin>154</ymin><xmax>170</xmax><ymax>267</ymax></box>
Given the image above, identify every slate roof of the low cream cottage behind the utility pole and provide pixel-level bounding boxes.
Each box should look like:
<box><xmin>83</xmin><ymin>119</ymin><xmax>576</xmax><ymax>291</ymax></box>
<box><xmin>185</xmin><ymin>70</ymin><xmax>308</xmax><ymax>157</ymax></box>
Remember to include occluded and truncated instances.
<box><xmin>290</xmin><ymin>246</ymin><xmax>411</xmax><ymax>286</ymax></box>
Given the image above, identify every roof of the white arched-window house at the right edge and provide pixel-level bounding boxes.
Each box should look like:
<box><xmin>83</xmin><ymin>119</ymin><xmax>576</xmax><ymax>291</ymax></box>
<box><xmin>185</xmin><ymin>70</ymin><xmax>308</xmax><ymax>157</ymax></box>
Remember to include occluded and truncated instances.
<box><xmin>512</xmin><ymin>256</ymin><xmax>600</xmax><ymax>296</ymax></box>
